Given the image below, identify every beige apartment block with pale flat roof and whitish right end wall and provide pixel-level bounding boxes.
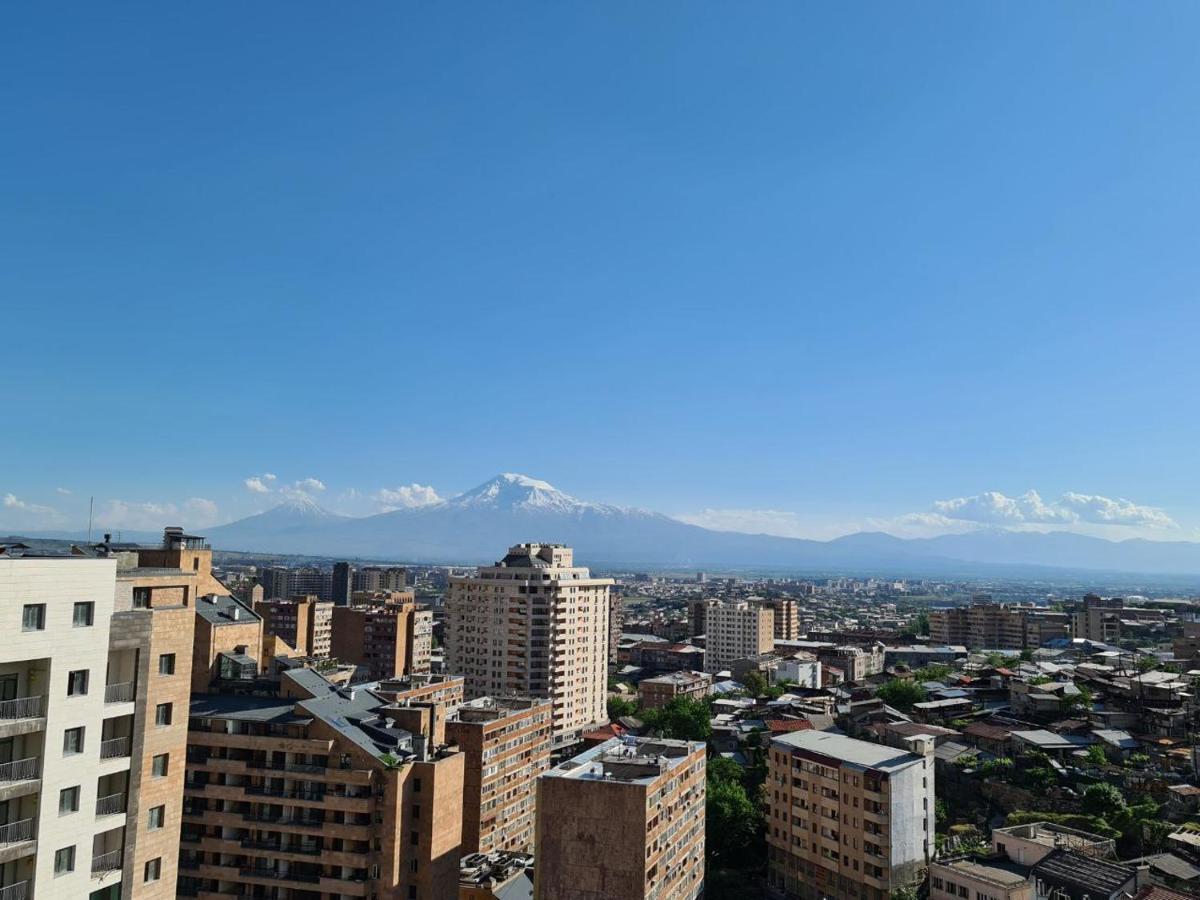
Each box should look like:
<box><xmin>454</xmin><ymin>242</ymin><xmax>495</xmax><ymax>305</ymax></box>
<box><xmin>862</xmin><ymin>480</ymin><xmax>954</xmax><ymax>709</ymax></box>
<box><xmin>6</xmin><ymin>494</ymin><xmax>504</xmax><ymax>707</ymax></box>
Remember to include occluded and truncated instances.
<box><xmin>767</xmin><ymin>731</ymin><xmax>934</xmax><ymax>900</ymax></box>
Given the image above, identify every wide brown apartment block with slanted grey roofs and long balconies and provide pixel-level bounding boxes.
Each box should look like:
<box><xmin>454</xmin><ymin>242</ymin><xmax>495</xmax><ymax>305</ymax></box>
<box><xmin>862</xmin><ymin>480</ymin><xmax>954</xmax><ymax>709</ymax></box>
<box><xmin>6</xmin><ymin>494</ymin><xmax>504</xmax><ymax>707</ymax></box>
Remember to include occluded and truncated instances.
<box><xmin>179</xmin><ymin>668</ymin><xmax>463</xmax><ymax>900</ymax></box>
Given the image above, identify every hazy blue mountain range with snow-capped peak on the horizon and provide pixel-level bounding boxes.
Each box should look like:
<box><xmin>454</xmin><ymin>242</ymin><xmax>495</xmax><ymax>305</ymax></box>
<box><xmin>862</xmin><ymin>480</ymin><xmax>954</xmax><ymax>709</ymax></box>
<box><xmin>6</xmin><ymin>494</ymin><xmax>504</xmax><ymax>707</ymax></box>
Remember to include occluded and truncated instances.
<box><xmin>187</xmin><ymin>473</ymin><xmax>1200</xmax><ymax>575</ymax></box>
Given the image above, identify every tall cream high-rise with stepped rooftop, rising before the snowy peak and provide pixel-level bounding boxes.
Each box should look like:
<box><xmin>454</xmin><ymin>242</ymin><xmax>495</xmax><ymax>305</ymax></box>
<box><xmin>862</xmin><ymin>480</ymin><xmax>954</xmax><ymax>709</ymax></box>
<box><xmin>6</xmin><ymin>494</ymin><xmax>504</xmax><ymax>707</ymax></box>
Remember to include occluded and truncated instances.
<box><xmin>445</xmin><ymin>544</ymin><xmax>613</xmax><ymax>745</ymax></box>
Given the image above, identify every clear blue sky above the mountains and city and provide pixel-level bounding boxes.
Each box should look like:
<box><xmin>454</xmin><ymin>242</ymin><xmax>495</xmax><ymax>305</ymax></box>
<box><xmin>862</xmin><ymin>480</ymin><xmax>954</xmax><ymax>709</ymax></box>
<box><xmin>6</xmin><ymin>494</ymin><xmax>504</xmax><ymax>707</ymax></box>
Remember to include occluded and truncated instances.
<box><xmin>0</xmin><ymin>2</ymin><xmax>1200</xmax><ymax>538</ymax></box>
